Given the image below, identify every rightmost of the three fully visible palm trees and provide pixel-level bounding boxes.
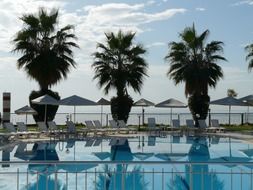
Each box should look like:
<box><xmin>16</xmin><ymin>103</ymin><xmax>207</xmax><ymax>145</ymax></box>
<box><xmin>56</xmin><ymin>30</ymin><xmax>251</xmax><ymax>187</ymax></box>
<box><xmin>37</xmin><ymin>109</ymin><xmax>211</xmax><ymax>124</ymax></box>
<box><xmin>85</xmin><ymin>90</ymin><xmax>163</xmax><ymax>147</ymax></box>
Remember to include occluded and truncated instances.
<box><xmin>165</xmin><ymin>25</ymin><xmax>226</xmax><ymax>123</ymax></box>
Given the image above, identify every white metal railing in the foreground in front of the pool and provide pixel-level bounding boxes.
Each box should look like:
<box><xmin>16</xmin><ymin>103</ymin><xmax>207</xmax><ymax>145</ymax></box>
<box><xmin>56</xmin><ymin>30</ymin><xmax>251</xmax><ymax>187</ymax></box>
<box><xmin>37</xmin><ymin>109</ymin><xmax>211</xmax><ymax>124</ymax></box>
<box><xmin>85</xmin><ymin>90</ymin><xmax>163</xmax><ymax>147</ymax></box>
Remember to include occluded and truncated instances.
<box><xmin>0</xmin><ymin>161</ymin><xmax>253</xmax><ymax>190</ymax></box>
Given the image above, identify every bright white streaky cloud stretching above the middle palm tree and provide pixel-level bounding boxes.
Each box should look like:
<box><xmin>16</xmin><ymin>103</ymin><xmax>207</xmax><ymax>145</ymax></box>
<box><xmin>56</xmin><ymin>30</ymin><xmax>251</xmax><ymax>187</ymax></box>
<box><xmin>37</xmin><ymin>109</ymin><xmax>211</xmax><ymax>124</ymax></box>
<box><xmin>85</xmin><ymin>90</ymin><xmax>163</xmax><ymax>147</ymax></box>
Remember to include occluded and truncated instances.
<box><xmin>60</xmin><ymin>3</ymin><xmax>186</xmax><ymax>67</ymax></box>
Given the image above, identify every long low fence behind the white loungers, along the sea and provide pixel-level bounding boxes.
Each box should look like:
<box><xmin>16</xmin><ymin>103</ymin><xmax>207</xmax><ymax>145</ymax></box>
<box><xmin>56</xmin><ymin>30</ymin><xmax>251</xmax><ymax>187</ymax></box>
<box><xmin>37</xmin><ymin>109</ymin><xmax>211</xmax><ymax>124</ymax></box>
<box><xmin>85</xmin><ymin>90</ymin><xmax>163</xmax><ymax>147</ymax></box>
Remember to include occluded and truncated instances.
<box><xmin>11</xmin><ymin>113</ymin><xmax>253</xmax><ymax>125</ymax></box>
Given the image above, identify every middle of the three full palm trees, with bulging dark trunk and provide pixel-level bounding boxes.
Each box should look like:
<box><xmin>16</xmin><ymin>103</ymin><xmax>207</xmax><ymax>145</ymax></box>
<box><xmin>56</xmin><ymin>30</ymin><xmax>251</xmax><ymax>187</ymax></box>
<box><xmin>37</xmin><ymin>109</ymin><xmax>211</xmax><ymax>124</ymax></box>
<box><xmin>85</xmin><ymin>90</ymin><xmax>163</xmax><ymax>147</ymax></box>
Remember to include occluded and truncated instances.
<box><xmin>92</xmin><ymin>30</ymin><xmax>148</xmax><ymax>121</ymax></box>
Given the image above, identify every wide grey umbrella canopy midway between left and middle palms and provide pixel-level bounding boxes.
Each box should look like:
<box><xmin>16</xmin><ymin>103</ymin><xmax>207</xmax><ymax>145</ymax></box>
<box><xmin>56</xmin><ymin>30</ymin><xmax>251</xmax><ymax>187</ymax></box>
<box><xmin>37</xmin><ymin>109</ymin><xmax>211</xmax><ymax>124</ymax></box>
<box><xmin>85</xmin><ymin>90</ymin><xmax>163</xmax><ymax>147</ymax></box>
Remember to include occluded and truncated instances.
<box><xmin>58</xmin><ymin>95</ymin><xmax>97</xmax><ymax>106</ymax></box>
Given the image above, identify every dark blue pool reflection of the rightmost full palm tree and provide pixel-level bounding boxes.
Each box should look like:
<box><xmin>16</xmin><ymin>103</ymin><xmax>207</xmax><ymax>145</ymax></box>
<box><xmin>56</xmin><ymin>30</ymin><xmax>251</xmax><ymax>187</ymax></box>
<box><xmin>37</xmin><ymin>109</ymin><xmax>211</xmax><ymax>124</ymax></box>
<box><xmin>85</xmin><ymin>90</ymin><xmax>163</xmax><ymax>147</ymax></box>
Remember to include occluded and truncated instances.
<box><xmin>168</xmin><ymin>137</ymin><xmax>224</xmax><ymax>190</ymax></box>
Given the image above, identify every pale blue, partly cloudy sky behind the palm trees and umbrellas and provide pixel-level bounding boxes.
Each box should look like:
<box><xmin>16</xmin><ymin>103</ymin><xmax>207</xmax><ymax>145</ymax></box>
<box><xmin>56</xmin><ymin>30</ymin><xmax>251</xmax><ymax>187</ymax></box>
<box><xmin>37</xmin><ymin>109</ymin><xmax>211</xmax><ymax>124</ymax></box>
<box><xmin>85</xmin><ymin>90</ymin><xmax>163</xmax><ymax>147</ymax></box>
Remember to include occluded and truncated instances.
<box><xmin>0</xmin><ymin>0</ymin><xmax>253</xmax><ymax>111</ymax></box>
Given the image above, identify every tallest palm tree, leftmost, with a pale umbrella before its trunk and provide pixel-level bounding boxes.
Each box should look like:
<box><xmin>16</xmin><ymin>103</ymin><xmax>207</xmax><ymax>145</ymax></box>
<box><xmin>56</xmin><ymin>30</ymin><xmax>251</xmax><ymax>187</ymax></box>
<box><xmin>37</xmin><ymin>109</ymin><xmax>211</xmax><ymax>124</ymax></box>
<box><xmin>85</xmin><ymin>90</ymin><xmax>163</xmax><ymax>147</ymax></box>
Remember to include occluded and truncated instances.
<box><xmin>13</xmin><ymin>8</ymin><xmax>78</xmax><ymax>120</ymax></box>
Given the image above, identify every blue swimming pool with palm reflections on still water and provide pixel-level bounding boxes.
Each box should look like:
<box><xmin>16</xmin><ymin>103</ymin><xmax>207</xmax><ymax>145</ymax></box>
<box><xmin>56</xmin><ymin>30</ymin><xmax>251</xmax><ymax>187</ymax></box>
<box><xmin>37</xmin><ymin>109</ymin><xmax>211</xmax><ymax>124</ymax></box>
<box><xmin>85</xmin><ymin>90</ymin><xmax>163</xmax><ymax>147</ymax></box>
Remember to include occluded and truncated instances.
<box><xmin>0</xmin><ymin>135</ymin><xmax>253</xmax><ymax>190</ymax></box>
